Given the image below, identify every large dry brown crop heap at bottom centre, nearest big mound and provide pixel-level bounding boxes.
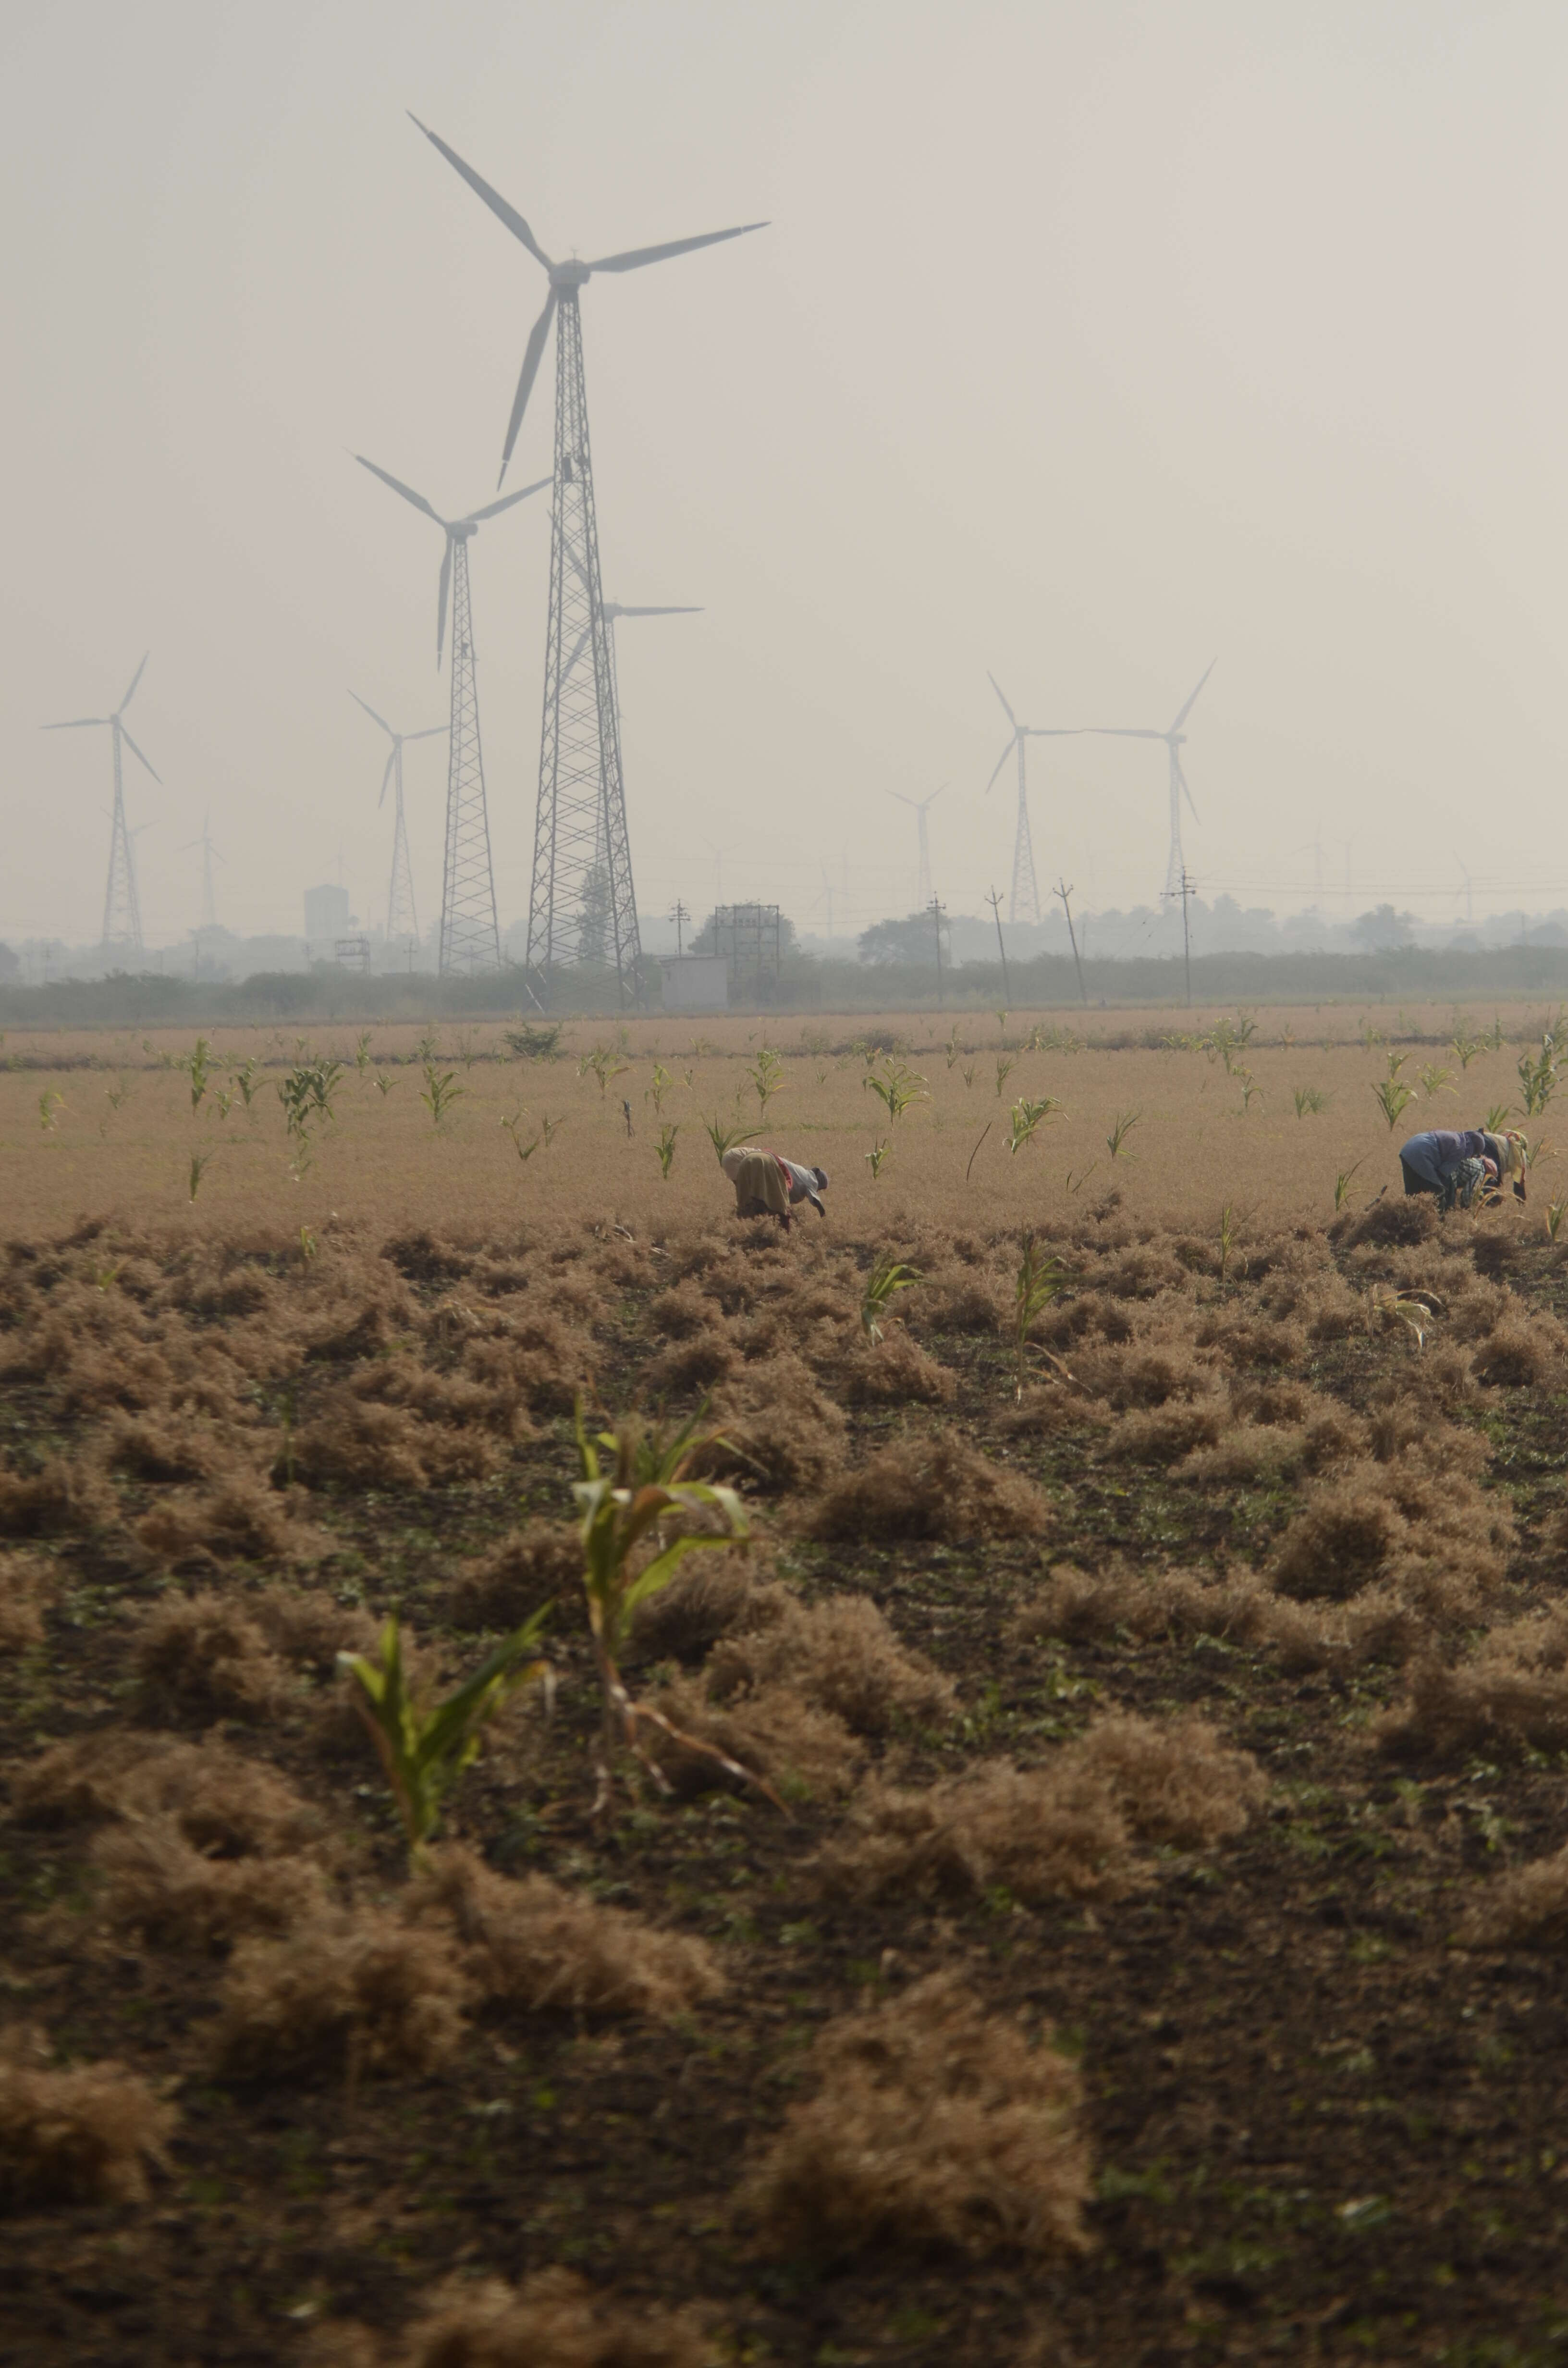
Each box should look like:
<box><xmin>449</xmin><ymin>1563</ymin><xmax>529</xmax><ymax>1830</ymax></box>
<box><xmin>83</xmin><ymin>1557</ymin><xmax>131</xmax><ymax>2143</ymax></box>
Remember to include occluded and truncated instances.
<box><xmin>746</xmin><ymin>1973</ymin><xmax>1090</xmax><ymax>2259</ymax></box>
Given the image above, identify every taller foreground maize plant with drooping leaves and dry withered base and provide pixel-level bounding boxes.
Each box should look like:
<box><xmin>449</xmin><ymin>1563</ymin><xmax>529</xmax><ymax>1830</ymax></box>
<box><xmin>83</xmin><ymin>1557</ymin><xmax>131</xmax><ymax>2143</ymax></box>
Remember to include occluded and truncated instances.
<box><xmin>571</xmin><ymin>1402</ymin><xmax>782</xmax><ymax>1816</ymax></box>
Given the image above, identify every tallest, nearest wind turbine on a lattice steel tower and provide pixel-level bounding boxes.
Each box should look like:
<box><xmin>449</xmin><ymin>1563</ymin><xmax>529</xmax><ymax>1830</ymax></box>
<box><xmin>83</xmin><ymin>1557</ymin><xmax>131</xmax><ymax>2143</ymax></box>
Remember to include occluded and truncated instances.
<box><xmin>415</xmin><ymin>116</ymin><xmax>765</xmax><ymax>1004</ymax></box>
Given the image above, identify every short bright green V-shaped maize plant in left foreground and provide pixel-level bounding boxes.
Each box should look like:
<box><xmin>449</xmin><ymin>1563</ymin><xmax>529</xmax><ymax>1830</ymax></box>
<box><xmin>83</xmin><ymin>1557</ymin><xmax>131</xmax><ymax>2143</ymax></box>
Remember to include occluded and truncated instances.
<box><xmin>339</xmin><ymin>1605</ymin><xmax>550</xmax><ymax>1859</ymax></box>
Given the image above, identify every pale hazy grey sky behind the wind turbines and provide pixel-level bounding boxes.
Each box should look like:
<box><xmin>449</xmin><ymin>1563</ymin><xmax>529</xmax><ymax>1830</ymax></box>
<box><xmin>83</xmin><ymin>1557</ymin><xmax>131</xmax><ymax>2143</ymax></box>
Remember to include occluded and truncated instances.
<box><xmin>0</xmin><ymin>0</ymin><xmax>1568</xmax><ymax>942</ymax></box>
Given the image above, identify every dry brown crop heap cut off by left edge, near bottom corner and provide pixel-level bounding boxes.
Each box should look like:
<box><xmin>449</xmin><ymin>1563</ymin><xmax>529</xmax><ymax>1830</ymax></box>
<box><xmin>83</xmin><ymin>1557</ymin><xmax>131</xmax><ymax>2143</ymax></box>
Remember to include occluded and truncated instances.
<box><xmin>0</xmin><ymin>2029</ymin><xmax>175</xmax><ymax>2212</ymax></box>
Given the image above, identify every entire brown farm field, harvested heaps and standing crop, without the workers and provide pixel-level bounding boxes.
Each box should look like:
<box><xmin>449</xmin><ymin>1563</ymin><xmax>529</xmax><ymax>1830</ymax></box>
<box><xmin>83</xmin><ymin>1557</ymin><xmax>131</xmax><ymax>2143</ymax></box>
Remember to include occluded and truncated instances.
<box><xmin>0</xmin><ymin>1004</ymin><xmax>1568</xmax><ymax>2368</ymax></box>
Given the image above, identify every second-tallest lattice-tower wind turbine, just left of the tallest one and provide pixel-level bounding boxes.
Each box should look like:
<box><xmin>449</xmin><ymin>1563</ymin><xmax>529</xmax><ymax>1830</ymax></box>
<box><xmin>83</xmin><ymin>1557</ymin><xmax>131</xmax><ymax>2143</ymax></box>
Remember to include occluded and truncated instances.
<box><xmin>355</xmin><ymin>452</ymin><xmax>550</xmax><ymax>978</ymax></box>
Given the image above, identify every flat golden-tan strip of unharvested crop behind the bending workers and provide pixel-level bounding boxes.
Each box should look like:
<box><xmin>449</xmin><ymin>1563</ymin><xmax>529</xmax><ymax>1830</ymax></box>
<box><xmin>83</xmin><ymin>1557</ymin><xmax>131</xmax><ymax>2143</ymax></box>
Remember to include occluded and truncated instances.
<box><xmin>0</xmin><ymin>1006</ymin><xmax>1554</xmax><ymax>1236</ymax></box>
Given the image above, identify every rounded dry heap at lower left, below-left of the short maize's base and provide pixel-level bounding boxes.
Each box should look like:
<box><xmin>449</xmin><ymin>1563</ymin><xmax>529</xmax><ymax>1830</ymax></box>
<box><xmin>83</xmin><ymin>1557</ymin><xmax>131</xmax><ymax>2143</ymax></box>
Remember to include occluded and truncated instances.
<box><xmin>213</xmin><ymin>1906</ymin><xmax>469</xmax><ymax>2079</ymax></box>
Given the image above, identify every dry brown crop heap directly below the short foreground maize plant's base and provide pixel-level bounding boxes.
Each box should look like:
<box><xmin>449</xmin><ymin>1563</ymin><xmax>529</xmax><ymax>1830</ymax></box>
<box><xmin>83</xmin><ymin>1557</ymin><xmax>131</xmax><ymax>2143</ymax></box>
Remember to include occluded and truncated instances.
<box><xmin>407</xmin><ymin>1842</ymin><xmax>725</xmax><ymax>2018</ymax></box>
